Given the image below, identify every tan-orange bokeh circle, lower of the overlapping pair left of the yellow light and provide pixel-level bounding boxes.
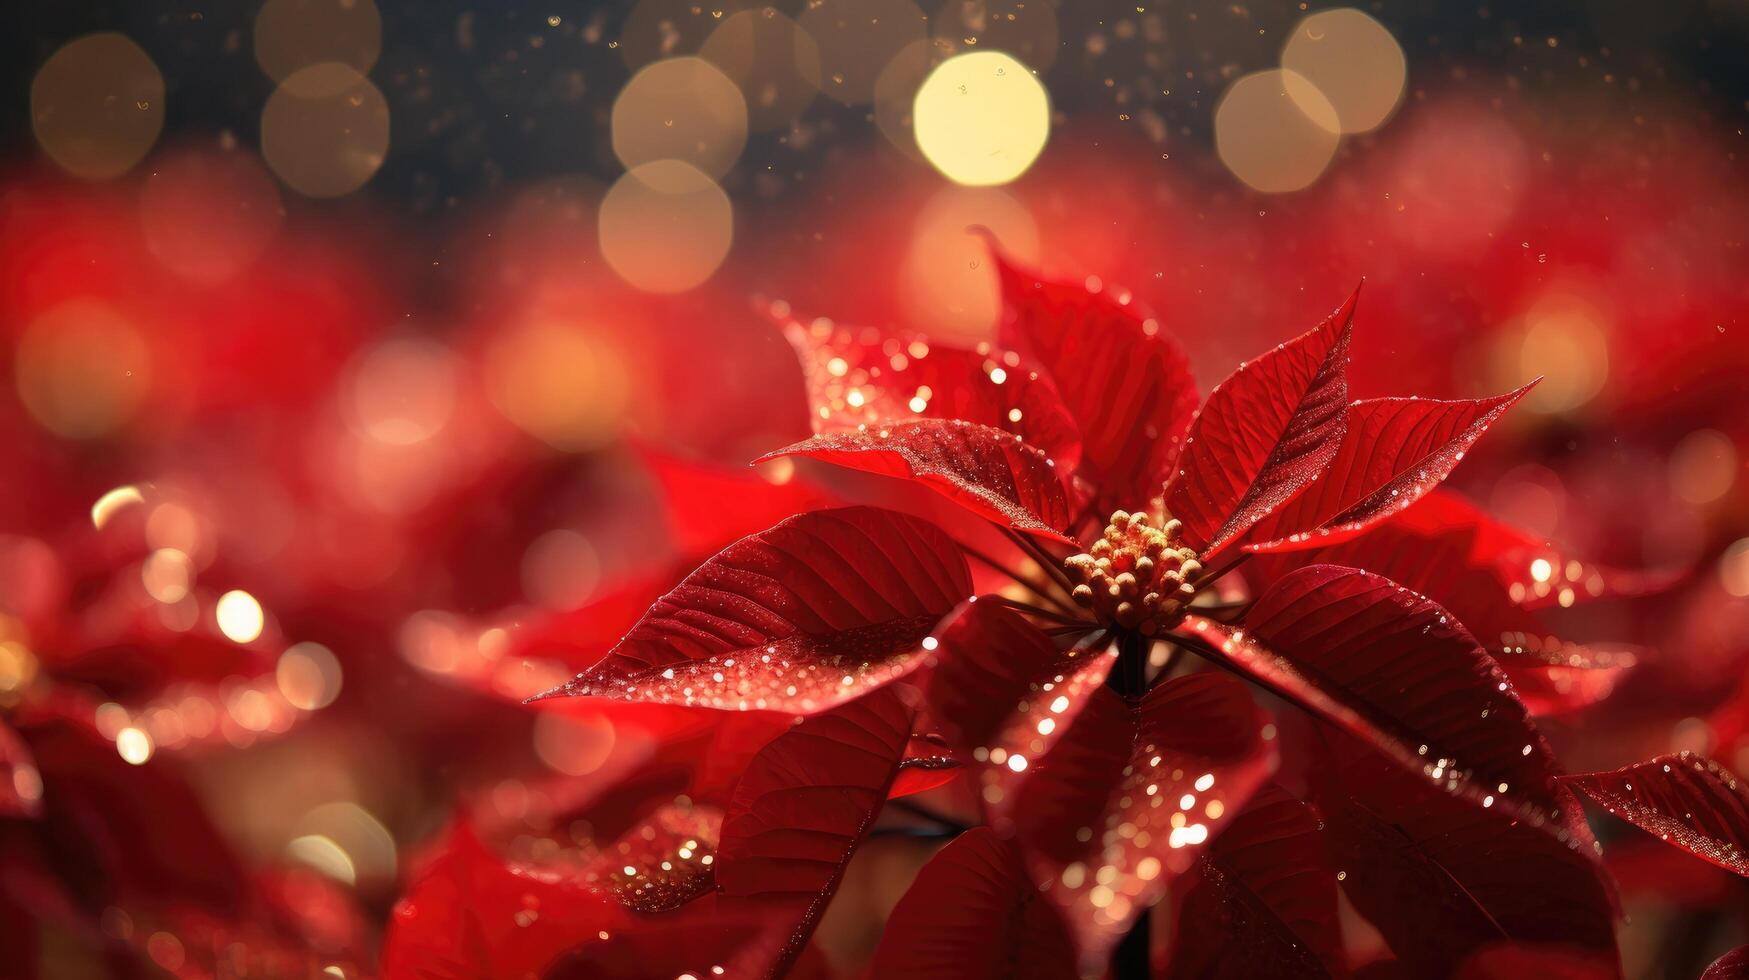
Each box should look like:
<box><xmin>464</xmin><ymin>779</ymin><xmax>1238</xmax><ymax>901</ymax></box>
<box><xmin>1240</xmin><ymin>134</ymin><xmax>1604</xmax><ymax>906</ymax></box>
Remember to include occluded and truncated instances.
<box><xmin>598</xmin><ymin>159</ymin><xmax>735</xmax><ymax>292</ymax></box>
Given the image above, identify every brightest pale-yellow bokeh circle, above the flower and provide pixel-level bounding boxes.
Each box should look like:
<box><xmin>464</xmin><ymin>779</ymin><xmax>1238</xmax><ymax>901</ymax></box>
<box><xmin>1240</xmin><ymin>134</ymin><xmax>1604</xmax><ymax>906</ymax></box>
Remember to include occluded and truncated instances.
<box><xmin>911</xmin><ymin>51</ymin><xmax>1051</xmax><ymax>187</ymax></box>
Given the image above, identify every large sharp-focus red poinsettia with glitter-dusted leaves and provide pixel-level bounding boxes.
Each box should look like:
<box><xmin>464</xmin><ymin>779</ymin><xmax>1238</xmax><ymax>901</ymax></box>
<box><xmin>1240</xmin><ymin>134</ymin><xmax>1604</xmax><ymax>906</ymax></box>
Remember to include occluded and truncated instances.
<box><xmin>388</xmin><ymin>259</ymin><xmax>1749</xmax><ymax>977</ymax></box>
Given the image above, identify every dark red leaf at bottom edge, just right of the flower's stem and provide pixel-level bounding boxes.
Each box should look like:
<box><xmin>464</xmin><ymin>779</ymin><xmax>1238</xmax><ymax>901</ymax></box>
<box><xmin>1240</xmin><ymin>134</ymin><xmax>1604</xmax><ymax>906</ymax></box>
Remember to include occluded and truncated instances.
<box><xmin>1167</xmin><ymin>786</ymin><xmax>1341</xmax><ymax>980</ymax></box>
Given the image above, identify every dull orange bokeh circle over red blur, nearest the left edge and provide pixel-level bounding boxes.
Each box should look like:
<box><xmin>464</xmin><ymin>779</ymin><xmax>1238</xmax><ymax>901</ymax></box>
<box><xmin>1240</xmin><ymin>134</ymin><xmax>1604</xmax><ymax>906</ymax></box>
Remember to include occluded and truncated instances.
<box><xmin>14</xmin><ymin>299</ymin><xmax>150</xmax><ymax>439</ymax></box>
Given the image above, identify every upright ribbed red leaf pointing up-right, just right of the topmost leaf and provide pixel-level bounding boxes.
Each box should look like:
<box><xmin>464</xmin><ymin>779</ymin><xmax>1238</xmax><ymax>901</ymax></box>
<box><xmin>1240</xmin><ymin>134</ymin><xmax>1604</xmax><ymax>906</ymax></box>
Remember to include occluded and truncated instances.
<box><xmin>1167</xmin><ymin>292</ymin><xmax>1359</xmax><ymax>555</ymax></box>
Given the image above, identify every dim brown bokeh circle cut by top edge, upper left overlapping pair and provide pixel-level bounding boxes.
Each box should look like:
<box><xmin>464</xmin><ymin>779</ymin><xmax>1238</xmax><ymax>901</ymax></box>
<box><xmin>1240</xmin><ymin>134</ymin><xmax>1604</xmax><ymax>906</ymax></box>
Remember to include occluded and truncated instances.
<box><xmin>255</xmin><ymin>0</ymin><xmax>383</xmax><ymax>96</ymax></box>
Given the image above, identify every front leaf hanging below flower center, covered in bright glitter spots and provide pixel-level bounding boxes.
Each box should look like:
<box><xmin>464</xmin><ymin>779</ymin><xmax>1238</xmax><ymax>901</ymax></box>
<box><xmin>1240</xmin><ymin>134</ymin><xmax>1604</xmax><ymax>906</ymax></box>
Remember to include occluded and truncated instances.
<box><xmin>985</xmin><ymin>672</ymin><xmax>1275</xmax><ymax>970</ymax></box>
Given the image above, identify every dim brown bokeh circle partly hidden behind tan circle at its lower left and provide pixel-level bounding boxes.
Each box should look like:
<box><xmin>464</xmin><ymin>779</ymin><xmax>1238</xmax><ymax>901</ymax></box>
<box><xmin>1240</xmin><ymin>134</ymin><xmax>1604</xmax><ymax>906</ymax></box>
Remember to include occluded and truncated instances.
<box><xmin>698</xmin><ymin>7</ymin><xmax>820</xmax><ymax>133</ymax></box>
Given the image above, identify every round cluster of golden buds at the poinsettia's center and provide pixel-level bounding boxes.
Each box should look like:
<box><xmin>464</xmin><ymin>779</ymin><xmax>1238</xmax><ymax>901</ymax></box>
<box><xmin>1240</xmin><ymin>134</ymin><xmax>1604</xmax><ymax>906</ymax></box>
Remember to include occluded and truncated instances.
<box><xmin>1063</xmin><ymin>511</ymin><xmax>1202</xmax><ymax>637</ymax></box>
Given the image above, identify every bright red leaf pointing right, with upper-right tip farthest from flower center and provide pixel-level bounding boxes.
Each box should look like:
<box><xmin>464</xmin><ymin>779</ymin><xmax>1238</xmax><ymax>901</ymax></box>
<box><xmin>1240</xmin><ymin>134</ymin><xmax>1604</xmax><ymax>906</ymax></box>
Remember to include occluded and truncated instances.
<box><xmin>1245</xmin><ymin>385</ymin><xmax>1532</xmax><ymax>551</ymax></box>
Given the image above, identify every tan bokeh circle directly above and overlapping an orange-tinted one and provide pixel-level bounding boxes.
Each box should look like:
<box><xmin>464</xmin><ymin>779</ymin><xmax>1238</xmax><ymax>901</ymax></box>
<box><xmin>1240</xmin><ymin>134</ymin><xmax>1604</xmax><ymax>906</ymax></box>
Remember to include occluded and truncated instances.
<box><xmin>612</xmin><ymin>58</ymin><xmax>747</xmax><ymax>177</ymax></box>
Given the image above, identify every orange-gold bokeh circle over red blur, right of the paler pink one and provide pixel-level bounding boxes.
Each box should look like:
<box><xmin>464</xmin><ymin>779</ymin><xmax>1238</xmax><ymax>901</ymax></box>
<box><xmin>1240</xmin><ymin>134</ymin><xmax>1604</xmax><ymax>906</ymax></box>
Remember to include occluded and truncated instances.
<box><xmin>484</xmin><ymin>319</ymin><xmax>630</xmax><ymax>452</ymax></box>
